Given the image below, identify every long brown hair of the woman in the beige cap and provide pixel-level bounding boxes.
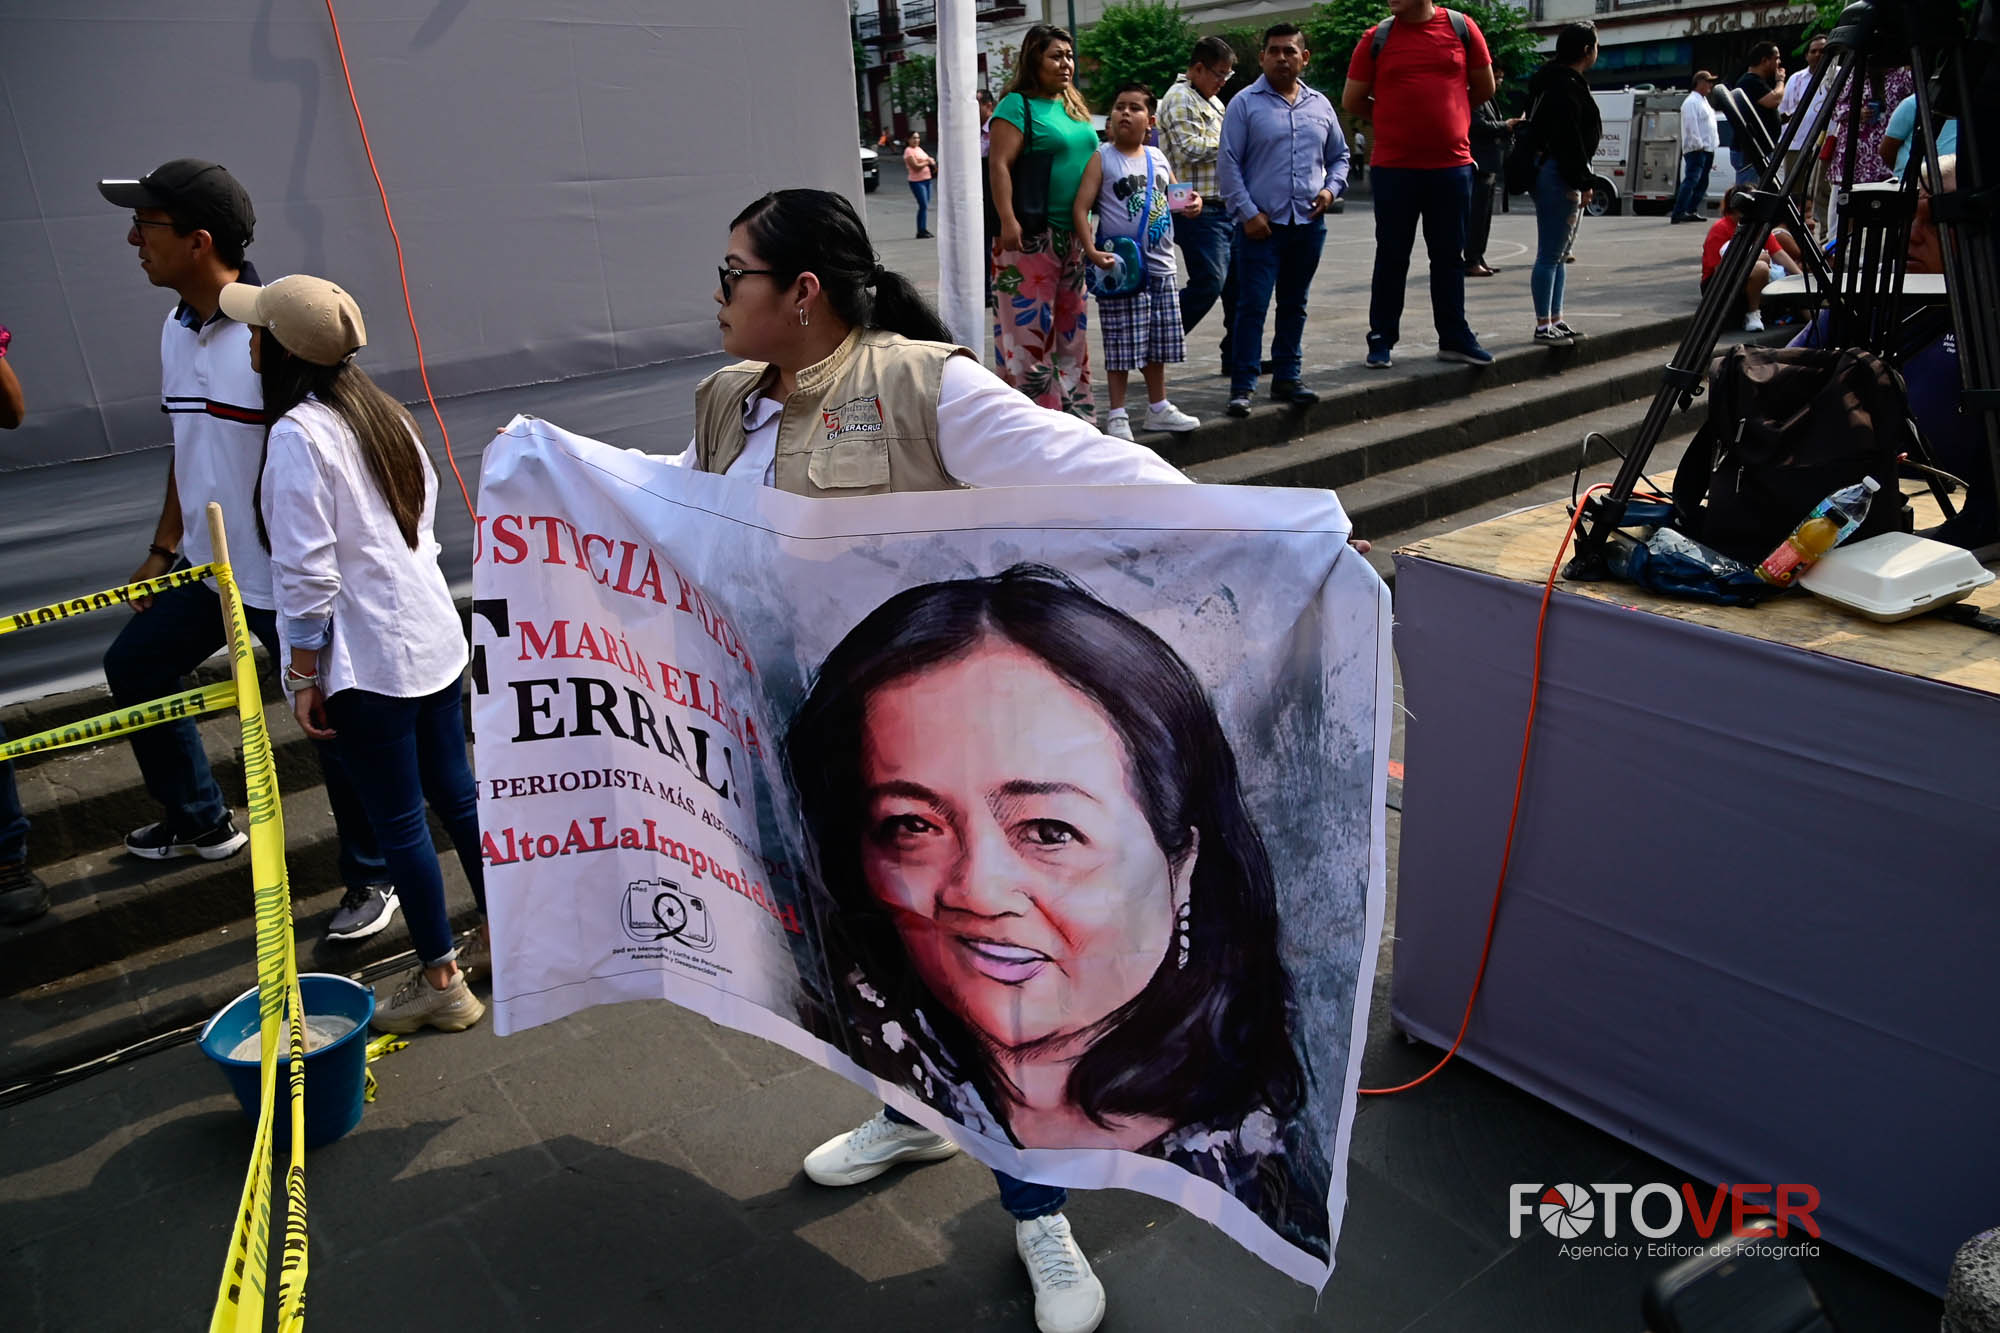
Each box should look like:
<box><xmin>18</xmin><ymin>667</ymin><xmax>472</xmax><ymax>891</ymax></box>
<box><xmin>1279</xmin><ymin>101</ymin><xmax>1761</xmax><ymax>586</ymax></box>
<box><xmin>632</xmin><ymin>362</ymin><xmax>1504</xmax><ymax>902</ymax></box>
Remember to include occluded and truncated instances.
<box><xmin>256</xmin><ymin>338</ymin><xmax>424</xmax><ymax>550</ymax></box>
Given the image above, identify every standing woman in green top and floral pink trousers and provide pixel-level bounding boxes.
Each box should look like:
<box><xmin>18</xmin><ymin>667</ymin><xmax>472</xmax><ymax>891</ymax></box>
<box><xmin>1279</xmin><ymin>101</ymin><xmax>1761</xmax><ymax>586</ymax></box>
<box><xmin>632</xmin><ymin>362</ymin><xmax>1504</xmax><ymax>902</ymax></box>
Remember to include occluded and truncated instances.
<box><xmin>986</xmin><ymin>24</ymin><xmax>1098</xmax><ymax>420</ymax></box>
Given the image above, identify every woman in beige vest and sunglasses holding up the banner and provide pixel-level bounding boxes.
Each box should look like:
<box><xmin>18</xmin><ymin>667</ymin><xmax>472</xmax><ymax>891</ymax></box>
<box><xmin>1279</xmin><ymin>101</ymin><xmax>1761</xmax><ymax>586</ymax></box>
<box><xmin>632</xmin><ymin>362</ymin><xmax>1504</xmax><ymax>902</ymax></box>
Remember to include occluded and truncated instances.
<box><xmin>676</xmin><ymin>190</ymin><xmax>1368</xmax><ymax>1333</ymax></box>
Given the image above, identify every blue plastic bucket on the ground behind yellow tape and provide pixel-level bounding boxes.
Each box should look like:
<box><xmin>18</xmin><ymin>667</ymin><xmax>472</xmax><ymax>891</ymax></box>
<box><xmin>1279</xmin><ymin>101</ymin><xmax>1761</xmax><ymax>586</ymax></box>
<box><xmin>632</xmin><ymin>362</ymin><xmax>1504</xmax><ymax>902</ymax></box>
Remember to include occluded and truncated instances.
<box><xmin>202</xmin><ymin>973</ymin><xmax>374</xmax><ymax>1149</ymax></box>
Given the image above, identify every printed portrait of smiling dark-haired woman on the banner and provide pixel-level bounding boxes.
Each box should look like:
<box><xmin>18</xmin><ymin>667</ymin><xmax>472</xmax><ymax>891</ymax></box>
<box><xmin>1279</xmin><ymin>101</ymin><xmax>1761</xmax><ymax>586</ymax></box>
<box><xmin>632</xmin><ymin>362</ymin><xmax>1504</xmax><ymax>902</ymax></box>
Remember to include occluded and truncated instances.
<box><xmin>784</xmin><ymin>564</ymin><xmax>1328</xmax><ymax>1257</ymax></box>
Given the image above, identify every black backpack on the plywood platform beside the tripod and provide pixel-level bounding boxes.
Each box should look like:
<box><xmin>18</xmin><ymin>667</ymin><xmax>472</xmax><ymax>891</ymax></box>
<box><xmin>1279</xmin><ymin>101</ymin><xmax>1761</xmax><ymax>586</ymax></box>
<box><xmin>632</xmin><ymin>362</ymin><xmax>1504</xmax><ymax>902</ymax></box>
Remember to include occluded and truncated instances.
<box><xmin>1674</xmin><ymin>346</ymin><xmax>1918</xmax><ymax>564</ymax></box>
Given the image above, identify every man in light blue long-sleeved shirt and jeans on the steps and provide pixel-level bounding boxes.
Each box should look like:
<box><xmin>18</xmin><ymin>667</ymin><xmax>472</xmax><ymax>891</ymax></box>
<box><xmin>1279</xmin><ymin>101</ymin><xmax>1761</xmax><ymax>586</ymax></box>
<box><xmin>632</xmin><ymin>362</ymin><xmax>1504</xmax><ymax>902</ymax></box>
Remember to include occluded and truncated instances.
<box><xmin>1216</xmin><ymin>24</ymin><xmax>1348</xmax><ymax>416</ymax></box>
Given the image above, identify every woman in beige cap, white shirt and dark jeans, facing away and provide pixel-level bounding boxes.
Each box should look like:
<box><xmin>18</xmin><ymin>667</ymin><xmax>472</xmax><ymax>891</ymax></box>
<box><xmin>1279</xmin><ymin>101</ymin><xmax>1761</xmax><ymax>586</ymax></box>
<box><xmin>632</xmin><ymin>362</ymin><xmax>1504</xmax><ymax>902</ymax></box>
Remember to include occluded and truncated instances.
<box><xmin>222</xmin><ymin>276</ymin><xmax>486</xmax><ymax>1033</ymax></box>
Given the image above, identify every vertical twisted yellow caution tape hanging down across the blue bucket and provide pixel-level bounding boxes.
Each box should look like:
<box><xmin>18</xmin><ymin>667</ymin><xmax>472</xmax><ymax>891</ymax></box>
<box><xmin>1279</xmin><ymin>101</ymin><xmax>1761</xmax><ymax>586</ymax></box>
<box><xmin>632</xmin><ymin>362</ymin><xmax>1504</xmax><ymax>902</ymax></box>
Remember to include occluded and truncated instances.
<box><xmin>208</xmin><ymin>504</ymin><xmax>306</xmax><ymax>1333</ymax></box>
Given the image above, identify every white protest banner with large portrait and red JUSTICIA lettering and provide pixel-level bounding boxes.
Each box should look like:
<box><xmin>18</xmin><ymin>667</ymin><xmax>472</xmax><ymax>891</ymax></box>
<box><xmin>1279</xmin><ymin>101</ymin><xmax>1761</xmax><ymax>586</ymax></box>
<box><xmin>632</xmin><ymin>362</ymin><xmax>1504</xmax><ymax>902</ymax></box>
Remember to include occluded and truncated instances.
<box><xmin>474</xmin><ymin>418</ymin><xmax>1392</xmax><ymax>1287</ymax></box>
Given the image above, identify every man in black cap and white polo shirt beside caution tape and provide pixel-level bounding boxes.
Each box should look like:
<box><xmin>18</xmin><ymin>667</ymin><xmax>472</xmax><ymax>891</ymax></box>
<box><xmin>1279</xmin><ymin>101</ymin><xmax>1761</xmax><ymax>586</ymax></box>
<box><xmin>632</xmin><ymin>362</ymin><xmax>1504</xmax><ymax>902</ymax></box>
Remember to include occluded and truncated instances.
<box><xmin>98</xmin><ymin>158</ymin><xmax>396</xmax><ymax>939</ymax></box>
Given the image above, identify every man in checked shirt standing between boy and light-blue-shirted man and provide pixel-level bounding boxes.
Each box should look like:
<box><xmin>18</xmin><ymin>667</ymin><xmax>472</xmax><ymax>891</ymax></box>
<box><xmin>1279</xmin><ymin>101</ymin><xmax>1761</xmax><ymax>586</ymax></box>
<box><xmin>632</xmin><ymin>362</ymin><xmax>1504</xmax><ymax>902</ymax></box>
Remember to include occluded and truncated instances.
<box><xmin>1158</xmin><ymin>36</ymin><xmax>1236</xmax><ymax>372</ymax></box>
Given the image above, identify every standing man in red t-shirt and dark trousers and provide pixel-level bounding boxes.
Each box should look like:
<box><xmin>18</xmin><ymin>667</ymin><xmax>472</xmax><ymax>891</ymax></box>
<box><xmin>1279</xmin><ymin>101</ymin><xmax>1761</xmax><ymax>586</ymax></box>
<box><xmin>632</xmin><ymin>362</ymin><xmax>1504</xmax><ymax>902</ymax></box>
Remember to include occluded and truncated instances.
<box><xmin>1340</xmin><ymin>0</ymin><xmax>1494</xmax><ymax>370</ymax></box>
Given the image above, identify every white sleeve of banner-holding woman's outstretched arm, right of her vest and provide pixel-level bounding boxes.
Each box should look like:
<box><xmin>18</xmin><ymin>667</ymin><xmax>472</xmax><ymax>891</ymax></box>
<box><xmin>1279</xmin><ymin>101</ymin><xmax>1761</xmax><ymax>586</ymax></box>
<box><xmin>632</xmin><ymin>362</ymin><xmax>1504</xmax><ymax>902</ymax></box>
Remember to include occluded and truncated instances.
<box><xmin>938</xmin><ymin>356</ymin><xmax>1188</xmax><ymax>486</ymax></box>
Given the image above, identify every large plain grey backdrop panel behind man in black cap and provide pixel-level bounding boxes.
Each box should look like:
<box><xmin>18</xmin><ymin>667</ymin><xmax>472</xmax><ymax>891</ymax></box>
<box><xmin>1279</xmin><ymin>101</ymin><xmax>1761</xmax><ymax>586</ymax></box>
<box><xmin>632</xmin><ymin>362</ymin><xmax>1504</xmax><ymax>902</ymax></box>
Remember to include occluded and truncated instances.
<box><xmin>0</xmin><ymin>0</ymin><xmax>860</xmax><ymax>470</ymax></box>
